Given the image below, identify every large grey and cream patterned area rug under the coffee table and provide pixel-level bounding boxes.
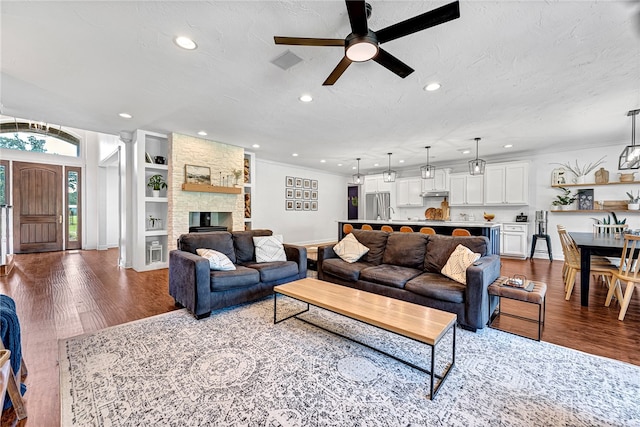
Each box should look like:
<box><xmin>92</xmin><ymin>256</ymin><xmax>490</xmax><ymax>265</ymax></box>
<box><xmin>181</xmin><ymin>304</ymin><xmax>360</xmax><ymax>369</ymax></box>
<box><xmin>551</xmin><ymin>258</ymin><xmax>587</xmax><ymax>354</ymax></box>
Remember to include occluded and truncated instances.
<box><xmin>59</xmin><ymin>297</ymin><xmax>640</xmax><ymax>427</ymax></box>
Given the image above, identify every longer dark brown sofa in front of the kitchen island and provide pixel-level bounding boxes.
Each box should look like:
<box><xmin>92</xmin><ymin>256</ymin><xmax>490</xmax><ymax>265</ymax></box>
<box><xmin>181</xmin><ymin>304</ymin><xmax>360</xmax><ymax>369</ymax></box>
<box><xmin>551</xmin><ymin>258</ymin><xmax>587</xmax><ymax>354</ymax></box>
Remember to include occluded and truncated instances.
<box><xmin>318</xmin><ymin>230</ymin><xmax>500</xmax><ymax>331</ymax></box>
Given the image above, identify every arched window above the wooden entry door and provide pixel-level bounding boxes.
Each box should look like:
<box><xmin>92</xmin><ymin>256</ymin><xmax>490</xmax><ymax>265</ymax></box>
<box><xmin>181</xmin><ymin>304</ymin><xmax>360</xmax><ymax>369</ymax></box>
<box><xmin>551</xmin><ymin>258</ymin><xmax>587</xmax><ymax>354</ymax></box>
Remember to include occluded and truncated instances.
<box><xmin>0</xmin><ymin>119</ymin><xmax>80</xmax><ymax>157</ymax></box>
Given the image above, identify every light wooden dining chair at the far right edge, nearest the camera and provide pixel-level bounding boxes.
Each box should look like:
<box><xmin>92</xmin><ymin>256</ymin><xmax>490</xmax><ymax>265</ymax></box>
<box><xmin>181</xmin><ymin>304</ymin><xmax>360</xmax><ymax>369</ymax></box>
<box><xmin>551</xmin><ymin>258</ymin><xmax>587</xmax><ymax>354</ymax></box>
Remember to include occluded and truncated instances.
<box><xmin>604</xmin><ymin>234</ymin><xmax>640</xmax><ymax>320</ymax></box>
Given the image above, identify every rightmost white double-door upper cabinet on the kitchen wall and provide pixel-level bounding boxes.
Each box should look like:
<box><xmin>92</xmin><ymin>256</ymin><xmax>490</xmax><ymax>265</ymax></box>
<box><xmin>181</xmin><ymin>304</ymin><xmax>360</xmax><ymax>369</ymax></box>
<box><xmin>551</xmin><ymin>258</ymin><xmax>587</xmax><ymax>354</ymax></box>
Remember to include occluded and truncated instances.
<box><xmin>484</xmin><ymin>162</ymin><xmax>529</xmax><ymax>205</ymax></box>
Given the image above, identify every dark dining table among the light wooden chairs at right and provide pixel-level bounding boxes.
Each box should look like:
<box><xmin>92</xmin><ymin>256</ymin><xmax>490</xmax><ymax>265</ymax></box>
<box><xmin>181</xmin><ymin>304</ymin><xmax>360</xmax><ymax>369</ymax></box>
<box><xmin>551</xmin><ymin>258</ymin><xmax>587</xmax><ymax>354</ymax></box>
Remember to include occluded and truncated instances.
<box><xmin>569</xmin><ymin>231</ymin><xmax>624</xmax><ymax>307</ymax></box>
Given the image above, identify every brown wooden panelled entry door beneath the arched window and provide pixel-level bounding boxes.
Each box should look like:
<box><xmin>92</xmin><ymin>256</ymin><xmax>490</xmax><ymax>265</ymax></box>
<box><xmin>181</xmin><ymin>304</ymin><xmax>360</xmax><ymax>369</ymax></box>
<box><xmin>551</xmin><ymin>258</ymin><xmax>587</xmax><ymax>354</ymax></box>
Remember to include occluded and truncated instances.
<box><xmin>13</xmin><ymin>162</ymin><xmax>64</xmax><ymax>253</ymax></box>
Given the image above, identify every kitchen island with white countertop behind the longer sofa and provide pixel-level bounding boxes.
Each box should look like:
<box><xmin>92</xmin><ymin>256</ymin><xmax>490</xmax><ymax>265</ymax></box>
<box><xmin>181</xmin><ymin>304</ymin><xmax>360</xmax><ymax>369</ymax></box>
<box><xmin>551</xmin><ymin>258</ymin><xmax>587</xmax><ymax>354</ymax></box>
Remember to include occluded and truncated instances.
<box><xmin>338</xmin><ymin>219</ymin><xmax>500</xmax><ymax>254</ymax></box>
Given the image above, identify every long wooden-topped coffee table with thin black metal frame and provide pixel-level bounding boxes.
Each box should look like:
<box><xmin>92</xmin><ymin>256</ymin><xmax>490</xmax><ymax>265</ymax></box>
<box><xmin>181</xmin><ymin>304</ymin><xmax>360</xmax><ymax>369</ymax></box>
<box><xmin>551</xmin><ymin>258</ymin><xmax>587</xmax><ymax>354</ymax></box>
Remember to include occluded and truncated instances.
<box><xmin>273</xmin><ymin>278</ymin><xmax>457</xmax><ymax>400</ymax></box>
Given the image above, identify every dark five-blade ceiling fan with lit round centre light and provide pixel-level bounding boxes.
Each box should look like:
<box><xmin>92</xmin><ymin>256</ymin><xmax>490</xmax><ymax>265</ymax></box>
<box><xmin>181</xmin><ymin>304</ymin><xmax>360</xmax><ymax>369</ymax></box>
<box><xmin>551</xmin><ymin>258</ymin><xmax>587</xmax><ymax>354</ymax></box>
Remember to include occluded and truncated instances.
<box><xmin>273</xmin><ymin>0</ymin><xmax>460</xmax><ymax>86</ymax></box>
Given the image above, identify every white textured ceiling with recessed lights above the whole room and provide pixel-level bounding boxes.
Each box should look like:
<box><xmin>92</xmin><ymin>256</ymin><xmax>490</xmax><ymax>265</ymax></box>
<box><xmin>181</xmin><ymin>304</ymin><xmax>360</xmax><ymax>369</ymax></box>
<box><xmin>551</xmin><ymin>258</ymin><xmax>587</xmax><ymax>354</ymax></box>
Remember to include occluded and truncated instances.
<box><xmin>0</xmin><ymin>0</ymin><xmax>640</xmax><ymax>174</ymax></box>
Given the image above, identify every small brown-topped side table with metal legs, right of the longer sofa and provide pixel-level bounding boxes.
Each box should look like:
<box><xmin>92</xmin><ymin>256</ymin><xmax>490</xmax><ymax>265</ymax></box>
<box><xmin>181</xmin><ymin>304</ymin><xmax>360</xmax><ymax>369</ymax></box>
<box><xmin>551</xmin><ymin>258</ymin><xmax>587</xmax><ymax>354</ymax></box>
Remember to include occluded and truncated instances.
<box><xmin>487</xmin><ymin>276</ymin><xmax>547</xmax><ymax>341</ymax></box>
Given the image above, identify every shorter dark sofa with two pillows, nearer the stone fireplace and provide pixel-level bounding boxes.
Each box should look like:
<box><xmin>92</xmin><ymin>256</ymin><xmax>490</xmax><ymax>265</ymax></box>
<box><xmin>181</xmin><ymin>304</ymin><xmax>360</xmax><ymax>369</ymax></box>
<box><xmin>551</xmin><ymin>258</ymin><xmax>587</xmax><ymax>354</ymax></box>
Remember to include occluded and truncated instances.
<box><xmin>169</xmin><ymin>230</ymin><xmax>307</xmax><ymax>319</ymax></box>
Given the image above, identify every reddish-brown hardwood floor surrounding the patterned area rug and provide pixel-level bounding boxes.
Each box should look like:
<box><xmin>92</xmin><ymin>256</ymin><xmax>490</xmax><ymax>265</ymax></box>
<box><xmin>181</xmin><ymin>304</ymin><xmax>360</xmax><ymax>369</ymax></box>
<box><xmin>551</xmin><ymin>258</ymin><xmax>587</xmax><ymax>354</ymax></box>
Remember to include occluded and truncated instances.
<box><xmin>0</xmin><ymin>250</ymin><xmax>640</xmax><ymax>427</ymax></box>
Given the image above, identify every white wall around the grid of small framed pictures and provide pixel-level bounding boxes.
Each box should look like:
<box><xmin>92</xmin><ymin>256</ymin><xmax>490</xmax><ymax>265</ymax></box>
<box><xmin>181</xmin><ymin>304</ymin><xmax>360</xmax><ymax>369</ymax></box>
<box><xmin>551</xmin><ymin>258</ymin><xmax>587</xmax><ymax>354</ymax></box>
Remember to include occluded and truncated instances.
<box><xmin>251</xmin><ymin>158</ymin><xmax>348</xmax><ymax>244</ymax></box>
